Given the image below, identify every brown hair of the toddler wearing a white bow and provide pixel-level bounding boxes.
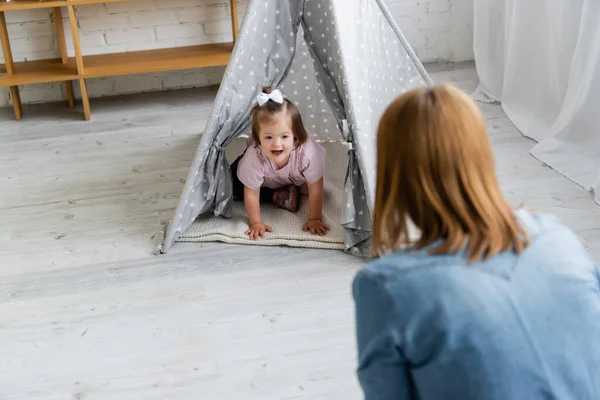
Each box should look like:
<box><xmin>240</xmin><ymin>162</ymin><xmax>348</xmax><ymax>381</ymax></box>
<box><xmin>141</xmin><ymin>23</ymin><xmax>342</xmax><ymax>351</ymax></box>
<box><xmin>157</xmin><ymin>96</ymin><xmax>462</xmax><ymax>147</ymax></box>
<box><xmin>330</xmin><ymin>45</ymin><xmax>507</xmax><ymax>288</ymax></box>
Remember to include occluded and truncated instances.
<box><xmin>250</xmin><ymin>86</ymin><xmax>308</xmax><ymax>146</ymax></box>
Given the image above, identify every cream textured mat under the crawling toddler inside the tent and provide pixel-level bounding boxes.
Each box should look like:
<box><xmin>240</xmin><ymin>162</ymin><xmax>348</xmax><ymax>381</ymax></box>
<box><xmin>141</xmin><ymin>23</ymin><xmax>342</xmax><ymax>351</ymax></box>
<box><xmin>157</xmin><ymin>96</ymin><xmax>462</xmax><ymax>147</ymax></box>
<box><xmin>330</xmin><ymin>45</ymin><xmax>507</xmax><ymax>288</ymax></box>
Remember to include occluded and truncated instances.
<box><xmin>179</xmin><ymin>140</ymin><xmax>348</xmax><ymax>249</ymax></box>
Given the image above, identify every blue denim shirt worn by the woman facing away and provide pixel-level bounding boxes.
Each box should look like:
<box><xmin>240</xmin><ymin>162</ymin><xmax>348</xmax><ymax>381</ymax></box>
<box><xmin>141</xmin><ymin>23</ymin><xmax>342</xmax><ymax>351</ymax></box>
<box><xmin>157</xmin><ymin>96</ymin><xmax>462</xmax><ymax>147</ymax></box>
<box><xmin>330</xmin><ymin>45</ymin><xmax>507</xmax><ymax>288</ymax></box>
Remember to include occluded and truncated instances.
<box><xmin>352</xmin><ymin>210</ymin><xmax>600</xmax><ymax>400</ymax></box>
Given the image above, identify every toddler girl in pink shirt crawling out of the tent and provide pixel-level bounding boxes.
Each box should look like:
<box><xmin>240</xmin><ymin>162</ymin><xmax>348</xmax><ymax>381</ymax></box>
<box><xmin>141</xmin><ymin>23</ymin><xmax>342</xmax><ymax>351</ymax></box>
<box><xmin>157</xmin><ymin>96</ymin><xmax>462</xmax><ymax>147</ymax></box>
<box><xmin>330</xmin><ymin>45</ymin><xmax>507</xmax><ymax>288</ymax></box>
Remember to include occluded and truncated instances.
<box><xmin>231</xmin><ymin>87</ymin><xmax>329</xmax><ymax>240</ymax></box>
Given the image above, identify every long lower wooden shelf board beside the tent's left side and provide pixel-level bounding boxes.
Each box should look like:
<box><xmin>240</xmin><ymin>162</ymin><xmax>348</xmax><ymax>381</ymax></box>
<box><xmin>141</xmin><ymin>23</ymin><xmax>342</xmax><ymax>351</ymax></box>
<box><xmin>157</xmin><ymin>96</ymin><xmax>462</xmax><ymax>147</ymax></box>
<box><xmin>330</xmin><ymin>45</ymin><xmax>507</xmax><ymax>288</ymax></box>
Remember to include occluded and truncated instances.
<box><xmin>83</xmin><ymin>43</ymin><xmax>233</xmax><ymax>78</ymax></box>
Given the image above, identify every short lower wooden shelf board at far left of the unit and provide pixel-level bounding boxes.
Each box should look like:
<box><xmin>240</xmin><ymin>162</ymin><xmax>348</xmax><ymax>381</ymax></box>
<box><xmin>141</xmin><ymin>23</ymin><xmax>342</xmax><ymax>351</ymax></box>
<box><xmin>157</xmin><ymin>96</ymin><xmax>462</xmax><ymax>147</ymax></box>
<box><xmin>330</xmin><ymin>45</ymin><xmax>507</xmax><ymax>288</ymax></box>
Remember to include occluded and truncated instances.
<box><xmin>0</xmin><ymin>58</ymin><xmax>79</xmax><ymax>86</ymax></box>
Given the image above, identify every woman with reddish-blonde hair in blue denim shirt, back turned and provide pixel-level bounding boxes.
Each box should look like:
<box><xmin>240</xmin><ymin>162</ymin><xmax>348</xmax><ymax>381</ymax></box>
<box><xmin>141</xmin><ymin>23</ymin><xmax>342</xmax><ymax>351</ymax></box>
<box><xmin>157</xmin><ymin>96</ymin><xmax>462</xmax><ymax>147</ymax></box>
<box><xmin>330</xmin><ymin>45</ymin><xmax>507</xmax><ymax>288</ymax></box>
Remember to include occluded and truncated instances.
<box><xmin>353</xmin><ymin>85</ymin><xmax>600</xmax><ymax>400</ymax></box>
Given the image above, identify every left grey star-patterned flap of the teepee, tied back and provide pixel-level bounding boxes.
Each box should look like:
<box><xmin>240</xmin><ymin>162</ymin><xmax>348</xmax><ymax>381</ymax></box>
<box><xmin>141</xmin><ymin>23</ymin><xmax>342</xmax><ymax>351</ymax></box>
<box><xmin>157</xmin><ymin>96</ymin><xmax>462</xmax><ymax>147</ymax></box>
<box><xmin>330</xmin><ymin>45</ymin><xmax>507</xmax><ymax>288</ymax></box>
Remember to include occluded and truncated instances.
<box><xmin>157</xmin><ymin>0</ymin><xmax>303</xmax><ymax>253</ymax></box>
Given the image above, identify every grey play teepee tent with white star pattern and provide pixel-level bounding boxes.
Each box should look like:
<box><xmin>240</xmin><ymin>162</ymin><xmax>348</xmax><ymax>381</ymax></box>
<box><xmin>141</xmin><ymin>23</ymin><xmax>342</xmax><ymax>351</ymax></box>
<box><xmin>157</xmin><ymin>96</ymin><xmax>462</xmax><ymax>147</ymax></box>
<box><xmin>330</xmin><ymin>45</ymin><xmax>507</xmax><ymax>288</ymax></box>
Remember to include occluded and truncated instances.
<box><xmin>157</xmin><ymin>0</ymin><xmax>431</xmax><ymax>255</ymax></box>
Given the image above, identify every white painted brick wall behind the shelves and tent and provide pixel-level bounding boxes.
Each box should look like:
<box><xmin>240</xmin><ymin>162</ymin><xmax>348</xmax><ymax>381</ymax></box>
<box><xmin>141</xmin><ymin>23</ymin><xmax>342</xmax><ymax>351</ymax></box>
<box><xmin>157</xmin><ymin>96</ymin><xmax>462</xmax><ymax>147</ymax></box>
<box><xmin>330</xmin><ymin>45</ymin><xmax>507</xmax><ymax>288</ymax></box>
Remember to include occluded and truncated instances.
<box><xmin>0</xmin><ymin>0</ymin><xmax>473</xmax><ymax>106</ymax></box>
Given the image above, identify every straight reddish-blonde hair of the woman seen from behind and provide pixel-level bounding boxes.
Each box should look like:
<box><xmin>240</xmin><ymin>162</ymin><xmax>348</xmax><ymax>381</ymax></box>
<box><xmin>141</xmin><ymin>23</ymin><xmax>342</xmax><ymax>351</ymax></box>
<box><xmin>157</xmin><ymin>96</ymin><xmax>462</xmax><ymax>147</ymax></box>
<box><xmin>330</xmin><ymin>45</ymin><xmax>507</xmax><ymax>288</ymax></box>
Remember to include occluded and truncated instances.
<box><xmin>372</xmin><ymin>85</ymin><xmax>529</xmax><ymax>262</ymax></box>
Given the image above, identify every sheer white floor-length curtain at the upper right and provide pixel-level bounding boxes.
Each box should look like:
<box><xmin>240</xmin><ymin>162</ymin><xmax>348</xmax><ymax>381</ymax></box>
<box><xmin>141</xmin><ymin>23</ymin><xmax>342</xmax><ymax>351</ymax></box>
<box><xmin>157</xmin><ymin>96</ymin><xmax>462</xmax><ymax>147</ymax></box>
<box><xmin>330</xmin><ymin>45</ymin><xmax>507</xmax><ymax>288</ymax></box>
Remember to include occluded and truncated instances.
<box><xmin>473</xmin><ymin>0</ymin><xmax>600</xmax><ymax>203</ymax></box>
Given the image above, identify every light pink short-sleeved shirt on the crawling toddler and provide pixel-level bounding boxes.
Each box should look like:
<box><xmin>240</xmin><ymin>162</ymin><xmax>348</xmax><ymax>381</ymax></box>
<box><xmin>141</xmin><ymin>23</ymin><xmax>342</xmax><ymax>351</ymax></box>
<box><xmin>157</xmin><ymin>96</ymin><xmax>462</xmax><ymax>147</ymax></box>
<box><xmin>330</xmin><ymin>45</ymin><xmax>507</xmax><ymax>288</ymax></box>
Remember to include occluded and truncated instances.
<box><xmin>237</xmin><ymin>133</ymin><xmax>326</xmax><ymax>190</ymax></box>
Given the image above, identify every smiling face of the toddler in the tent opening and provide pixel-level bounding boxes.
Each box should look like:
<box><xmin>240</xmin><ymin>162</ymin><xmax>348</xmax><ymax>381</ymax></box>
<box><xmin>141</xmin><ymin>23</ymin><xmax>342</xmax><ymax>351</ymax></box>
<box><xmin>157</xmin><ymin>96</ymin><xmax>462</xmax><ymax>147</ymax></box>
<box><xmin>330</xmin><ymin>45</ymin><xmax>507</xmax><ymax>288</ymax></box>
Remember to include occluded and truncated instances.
<box><xmin>259</xmin><ymin>114</ymin><xmax>294</xmax><ymax>168</ymax></box>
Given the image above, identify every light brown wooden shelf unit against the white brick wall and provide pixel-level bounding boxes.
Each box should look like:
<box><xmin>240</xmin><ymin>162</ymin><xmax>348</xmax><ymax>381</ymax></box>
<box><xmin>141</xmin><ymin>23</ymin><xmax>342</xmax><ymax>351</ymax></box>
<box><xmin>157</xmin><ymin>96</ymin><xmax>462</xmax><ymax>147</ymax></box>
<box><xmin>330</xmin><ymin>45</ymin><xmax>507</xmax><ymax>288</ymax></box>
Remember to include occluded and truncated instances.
<box><xmin>0</xmin><ymin>0</ymin><xmax>238</xmax><ymax>120</ymax></box>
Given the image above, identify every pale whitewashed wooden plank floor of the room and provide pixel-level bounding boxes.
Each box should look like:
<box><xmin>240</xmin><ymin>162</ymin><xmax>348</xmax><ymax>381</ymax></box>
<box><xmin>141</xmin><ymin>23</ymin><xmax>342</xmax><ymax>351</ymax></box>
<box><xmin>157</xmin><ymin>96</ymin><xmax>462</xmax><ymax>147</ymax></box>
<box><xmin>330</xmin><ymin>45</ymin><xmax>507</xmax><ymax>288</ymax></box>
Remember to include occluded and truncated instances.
<box><xmin>0</xmin><ymin>63</ymin><xmax>600</xmax><ymax>400</ymax></box>
